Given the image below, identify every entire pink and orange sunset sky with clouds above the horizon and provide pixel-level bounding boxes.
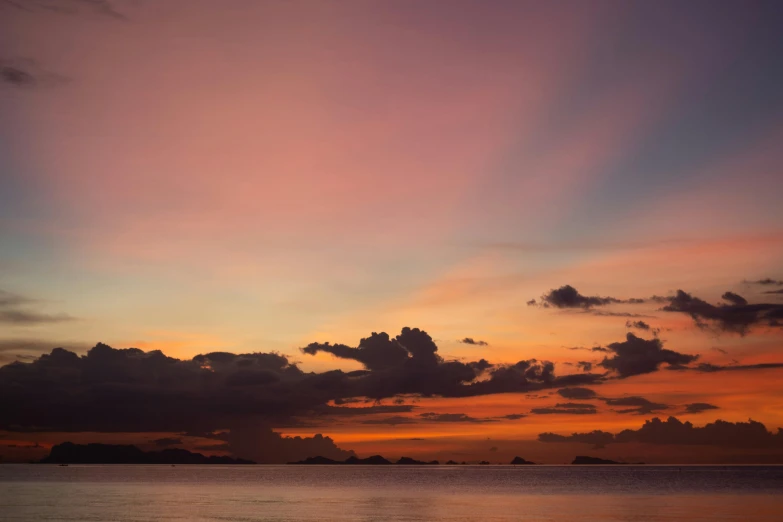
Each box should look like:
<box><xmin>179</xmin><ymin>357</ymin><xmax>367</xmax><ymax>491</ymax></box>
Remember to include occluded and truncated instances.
<box><xmin>0</xmin><ymin>0</ymin><xmax>783</xmax><ymax>463</ymax></box>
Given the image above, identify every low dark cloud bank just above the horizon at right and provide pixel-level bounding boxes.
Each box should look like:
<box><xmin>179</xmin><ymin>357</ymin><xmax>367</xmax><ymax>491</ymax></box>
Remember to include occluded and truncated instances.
<box><xmin>538</xmin><ymin>417</ymin><xmax>783</xmax><ymax>448</ymax></box>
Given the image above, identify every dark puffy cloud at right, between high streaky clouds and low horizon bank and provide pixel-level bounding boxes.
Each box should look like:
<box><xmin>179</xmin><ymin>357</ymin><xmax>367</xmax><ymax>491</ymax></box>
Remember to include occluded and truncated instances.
<box><xmin>598</xmin><ymin>333</ymin><xmax>698</xmax><ymax>377</ymax></box>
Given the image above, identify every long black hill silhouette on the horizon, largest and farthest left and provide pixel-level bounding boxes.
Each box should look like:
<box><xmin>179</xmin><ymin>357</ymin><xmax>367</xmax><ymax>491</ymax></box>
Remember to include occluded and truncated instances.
<box><xmin>41</xmin><ymin>442</ymin><xmax>255</xmax><ymax>464</ymax></box>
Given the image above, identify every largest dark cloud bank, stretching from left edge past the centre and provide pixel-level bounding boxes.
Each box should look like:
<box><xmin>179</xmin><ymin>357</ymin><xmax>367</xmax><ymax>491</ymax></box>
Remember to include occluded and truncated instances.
<box><xmin>0</xmin><ymin>328</ymin><xmax>604</xmax><ymax>434</ymax></box>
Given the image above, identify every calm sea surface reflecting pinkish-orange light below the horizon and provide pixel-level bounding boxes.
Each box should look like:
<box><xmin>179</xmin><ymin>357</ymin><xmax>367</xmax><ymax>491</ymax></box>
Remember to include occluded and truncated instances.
<box><xmin>0</xmin><ymin>464</ymin><xmax>783</xmax><ymax>522</ymax></box>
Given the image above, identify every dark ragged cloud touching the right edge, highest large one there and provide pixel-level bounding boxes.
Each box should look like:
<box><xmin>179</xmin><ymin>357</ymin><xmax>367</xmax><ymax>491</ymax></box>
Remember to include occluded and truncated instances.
<box><xmin>661</xmin><ymin>290</ymin><xmax>783</xmax><ymax>335</ymax></box>
